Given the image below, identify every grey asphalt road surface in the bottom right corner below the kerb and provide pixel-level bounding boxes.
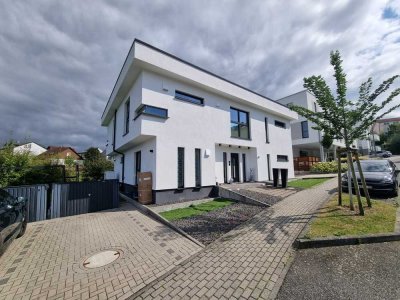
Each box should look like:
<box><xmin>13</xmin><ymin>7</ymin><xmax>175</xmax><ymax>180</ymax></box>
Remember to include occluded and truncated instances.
<box><xmin>277</xmin><ymin>242</ymin><xmax>400</xmax><ymax>300</ymax></box>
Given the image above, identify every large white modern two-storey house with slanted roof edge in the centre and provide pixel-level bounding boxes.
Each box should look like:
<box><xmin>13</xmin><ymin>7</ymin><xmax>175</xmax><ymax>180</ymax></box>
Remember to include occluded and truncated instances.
<box><xmin>101</xmin><ymin>40</ymin><xmax>297</xmax><ymax>203</ymax></box>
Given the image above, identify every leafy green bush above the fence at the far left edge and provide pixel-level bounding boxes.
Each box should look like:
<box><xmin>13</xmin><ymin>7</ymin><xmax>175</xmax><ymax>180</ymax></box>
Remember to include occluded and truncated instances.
<box><xmin>0</xmin><ymin>143</ymin><xmax>32</xmax><ymax>187</ymax></box>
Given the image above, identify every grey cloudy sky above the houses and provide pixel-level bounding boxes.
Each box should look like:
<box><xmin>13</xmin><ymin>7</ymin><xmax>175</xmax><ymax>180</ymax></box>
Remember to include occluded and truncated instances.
<box><xmin>0</xmin><ymin>0</ymin><xmax>400</xmax><ymax>150</ymax></box>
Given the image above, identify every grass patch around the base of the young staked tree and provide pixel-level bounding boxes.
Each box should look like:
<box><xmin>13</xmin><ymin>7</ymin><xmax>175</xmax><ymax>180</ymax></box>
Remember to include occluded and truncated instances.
<box><xmin>305</xmin><ymin>194</ymin><xmax>397</xmax><ymax>238</ymax></box>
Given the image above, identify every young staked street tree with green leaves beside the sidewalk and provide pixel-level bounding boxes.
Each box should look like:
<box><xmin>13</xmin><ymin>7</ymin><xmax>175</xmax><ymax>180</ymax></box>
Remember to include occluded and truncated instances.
<box><xmin>289</xmin><ymin>51</ymin><xmax>400</xmax><ymax>215</ymax></box>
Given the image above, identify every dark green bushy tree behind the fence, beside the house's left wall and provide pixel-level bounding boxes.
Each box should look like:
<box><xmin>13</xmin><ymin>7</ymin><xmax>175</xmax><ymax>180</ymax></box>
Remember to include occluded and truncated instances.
<box><xmin>84</xmin><ymin>148</ymin><xmax>114</xmax><ymax>180</ymax></box>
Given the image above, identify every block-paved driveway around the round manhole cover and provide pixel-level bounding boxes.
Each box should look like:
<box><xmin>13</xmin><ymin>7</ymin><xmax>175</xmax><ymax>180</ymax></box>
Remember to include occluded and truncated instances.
<box><xmin>0</xmin><ymin>204</ymin><xmax>202</xmax><ymax>299</ymax></box>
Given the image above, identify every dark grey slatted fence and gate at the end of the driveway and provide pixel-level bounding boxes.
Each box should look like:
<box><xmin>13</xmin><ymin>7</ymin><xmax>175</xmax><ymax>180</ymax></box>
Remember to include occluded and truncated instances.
<box><xmin>5</xmin><ymin>179</ymin><xmax>119</xmax><ymax>222</ymax></box>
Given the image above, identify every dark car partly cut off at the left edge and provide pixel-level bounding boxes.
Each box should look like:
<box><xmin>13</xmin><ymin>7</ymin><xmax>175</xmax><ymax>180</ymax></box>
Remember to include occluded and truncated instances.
<box><xmin>0</xmin><ymin>189</ymin><xmax>27</xmax><ymax>255</ymax></box>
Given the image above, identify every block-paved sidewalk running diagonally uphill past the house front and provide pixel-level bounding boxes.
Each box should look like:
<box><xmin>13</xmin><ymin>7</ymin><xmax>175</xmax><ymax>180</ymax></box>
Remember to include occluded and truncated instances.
<box><xmin>131</xmin><ymin>179</ymin><xmax>336</xmax><ymax>299</ymax></box>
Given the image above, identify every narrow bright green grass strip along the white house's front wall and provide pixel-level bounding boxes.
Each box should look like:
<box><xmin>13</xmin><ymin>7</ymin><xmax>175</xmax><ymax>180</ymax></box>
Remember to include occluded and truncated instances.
<box><xmin>160</xmin><ymin>198</ymin><xmax>234</xmax><ymax>221</ymax></box>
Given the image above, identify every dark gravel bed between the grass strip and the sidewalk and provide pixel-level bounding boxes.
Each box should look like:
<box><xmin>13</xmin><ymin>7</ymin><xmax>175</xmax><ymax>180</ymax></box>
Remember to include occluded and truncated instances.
<box><xmin>171</xmin><ymin>202</ymin><xmax>264</xmax><ymax>245</ymax></box>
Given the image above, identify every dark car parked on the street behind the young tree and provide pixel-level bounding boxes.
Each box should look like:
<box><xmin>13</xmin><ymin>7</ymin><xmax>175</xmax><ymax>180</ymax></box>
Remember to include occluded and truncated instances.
<box><xmin>342</xmin><ymin>159</ymin><xmax>399</xmax><ymax>196</ymax></box>
